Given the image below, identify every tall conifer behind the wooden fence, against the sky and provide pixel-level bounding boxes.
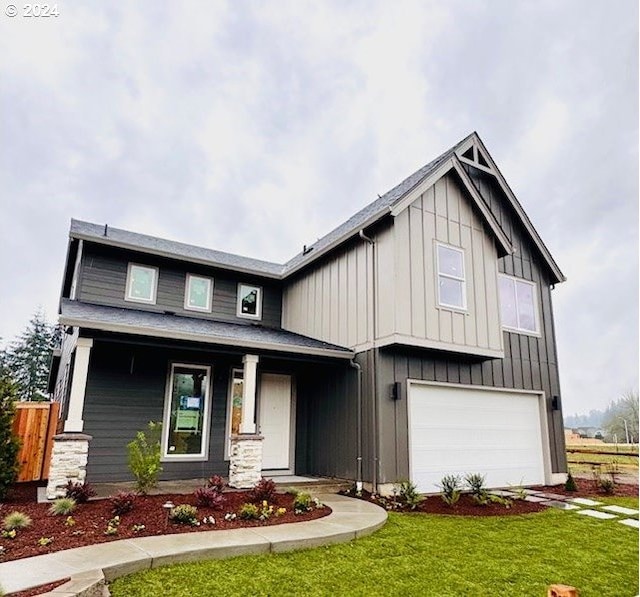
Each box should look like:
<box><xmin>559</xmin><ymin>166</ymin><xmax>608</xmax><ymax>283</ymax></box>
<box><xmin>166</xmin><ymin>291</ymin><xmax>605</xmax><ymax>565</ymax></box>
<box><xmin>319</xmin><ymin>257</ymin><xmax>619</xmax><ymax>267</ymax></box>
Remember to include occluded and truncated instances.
<box><xmin>4</xmin><ymin>310</ymin><xmax>60</xmax><ymax>400</ymax></box>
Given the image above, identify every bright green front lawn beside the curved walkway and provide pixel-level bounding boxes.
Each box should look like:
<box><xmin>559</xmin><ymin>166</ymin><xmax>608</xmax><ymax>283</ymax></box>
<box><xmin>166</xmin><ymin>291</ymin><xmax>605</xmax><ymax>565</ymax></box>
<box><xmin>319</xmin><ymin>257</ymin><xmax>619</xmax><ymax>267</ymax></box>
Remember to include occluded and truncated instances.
<box><xmin>111</xmin><ymin>508</ymin><xmax>638</xmax><ymax>597</ymax></box>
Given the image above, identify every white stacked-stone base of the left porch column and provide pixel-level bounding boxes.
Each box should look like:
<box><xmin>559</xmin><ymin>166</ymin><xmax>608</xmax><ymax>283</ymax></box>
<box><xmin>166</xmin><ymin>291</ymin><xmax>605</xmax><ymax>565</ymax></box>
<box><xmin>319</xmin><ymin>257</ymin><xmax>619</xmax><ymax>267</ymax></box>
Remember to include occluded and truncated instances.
<box><xmin>47</xmin><ymin>433</ymin><xmax>93</xmax><ymax>500</ymax></box>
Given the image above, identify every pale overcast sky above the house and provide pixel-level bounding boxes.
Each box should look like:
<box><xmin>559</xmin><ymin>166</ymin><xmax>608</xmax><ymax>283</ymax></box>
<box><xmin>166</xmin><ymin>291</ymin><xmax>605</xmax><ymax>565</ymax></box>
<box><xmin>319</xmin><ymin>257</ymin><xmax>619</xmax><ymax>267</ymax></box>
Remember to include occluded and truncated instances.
<box><xmin>0</xmin><ymin>0</ymin><xmax>638</xmax><ymax>414</ymax></box>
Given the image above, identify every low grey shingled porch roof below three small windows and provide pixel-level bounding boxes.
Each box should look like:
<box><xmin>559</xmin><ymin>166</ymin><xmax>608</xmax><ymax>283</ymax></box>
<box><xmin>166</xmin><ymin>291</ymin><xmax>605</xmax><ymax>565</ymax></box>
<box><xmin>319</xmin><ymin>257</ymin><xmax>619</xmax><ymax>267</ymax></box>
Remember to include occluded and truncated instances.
<box><xmin>60</xmin><ymin>299</ymin><xmax>354</xmax><ymax>359</ymax></box>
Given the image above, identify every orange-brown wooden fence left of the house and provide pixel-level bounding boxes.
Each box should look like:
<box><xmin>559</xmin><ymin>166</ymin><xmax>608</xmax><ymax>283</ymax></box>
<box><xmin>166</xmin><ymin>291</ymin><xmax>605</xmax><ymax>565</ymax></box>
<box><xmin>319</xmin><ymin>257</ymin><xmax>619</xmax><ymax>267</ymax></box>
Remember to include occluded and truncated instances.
<box><xmin>13</xmin><ymin>402</ymin><xmax>60</xmax><ymax>481</ymax></box>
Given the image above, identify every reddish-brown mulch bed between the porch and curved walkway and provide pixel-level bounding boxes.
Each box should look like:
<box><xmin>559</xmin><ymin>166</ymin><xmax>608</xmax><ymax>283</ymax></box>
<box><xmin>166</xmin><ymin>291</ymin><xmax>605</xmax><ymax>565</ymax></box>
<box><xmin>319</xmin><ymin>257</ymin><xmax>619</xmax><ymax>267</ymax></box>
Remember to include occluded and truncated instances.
<box><xmin>0</xmin><ymin>485</ymin><xmax>331</xmax><ymax>562</ymax></box>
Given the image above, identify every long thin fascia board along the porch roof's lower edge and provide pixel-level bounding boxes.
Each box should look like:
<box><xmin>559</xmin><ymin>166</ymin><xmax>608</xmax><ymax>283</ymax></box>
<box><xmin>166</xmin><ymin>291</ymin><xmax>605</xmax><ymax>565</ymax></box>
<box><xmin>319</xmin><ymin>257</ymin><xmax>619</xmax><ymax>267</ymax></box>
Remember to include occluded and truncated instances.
<box><xmin>60</xmin><ymin>316</ymin><xmax>355</xmax><ymax>359</ymax></box>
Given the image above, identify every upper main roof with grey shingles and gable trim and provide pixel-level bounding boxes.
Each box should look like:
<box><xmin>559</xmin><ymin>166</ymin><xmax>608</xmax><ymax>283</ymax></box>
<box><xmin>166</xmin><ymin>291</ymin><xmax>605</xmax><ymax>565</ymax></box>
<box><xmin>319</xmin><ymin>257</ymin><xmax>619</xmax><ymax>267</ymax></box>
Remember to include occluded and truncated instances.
<box><xmin>70</xmin><ymin>132</ymin><xmax>566</xmax><ymax>282</ymax></box>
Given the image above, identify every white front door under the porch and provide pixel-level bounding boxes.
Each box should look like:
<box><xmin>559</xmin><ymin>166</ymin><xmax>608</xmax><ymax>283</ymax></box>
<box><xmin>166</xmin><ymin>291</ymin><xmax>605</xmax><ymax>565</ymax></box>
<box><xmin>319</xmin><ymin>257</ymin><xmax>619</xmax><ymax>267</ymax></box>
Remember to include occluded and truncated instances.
<box><xmin>258</xmin><ymin>373</ymin><xmax>293</xmax><ymax>470</ymax></box>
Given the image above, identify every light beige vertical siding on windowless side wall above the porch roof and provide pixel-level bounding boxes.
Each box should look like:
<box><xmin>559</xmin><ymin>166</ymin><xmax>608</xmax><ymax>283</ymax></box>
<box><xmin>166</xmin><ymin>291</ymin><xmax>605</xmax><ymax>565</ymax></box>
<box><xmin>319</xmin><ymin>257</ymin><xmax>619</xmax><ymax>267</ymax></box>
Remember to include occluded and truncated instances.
<box><xmin>282</xmin><ymin>240</ymin><xmax>373</xmax><ymax>350</ymax></box>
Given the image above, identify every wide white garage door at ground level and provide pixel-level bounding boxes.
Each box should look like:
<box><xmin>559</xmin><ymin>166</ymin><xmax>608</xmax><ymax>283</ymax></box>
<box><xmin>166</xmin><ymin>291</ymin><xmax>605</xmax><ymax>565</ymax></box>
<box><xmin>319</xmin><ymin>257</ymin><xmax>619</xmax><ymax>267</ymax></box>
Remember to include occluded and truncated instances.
<box><xmin>409</xmin><ymin>384</ymin><xmax>544</xmax><ymax>493</ymax></box>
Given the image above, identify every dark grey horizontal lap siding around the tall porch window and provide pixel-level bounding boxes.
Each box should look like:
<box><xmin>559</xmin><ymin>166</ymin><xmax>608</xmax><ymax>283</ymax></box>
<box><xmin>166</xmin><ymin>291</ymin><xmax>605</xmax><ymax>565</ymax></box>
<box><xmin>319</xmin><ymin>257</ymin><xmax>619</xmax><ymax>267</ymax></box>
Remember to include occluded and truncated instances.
<box><xmin>84</xmin><ymin>341</ymin><xmax>234</xmax><ymax>482</ymax></box>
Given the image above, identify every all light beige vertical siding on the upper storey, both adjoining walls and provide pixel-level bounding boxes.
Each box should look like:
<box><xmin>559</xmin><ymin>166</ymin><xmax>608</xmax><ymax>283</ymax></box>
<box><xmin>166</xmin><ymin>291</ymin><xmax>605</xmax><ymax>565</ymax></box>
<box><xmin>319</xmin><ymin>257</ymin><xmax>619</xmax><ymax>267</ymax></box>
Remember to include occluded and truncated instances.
<box><xmin>282</xmin><ymin>175</ymin><xmax>503</xmax><ymax>356</ymax></box>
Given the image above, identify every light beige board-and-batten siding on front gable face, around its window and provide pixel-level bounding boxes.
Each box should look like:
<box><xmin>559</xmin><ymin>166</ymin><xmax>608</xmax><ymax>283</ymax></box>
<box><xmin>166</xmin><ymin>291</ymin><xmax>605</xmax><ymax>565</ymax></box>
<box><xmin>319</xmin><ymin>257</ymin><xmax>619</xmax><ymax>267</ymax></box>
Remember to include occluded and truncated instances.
<box><xmin>377</xmin><ymin>174</ymin><xmax>503</xmax><ymax>354</ymax></box>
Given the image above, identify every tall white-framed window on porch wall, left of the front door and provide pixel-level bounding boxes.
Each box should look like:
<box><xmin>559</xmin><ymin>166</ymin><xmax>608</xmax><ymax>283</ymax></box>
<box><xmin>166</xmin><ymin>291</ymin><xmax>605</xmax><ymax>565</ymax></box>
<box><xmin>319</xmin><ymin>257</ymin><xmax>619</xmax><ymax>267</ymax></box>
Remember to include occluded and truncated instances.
<box><xmin>163</xmin><ymin>363</ymin><xmax>211</xmax><ymax>460</ymax></box>
